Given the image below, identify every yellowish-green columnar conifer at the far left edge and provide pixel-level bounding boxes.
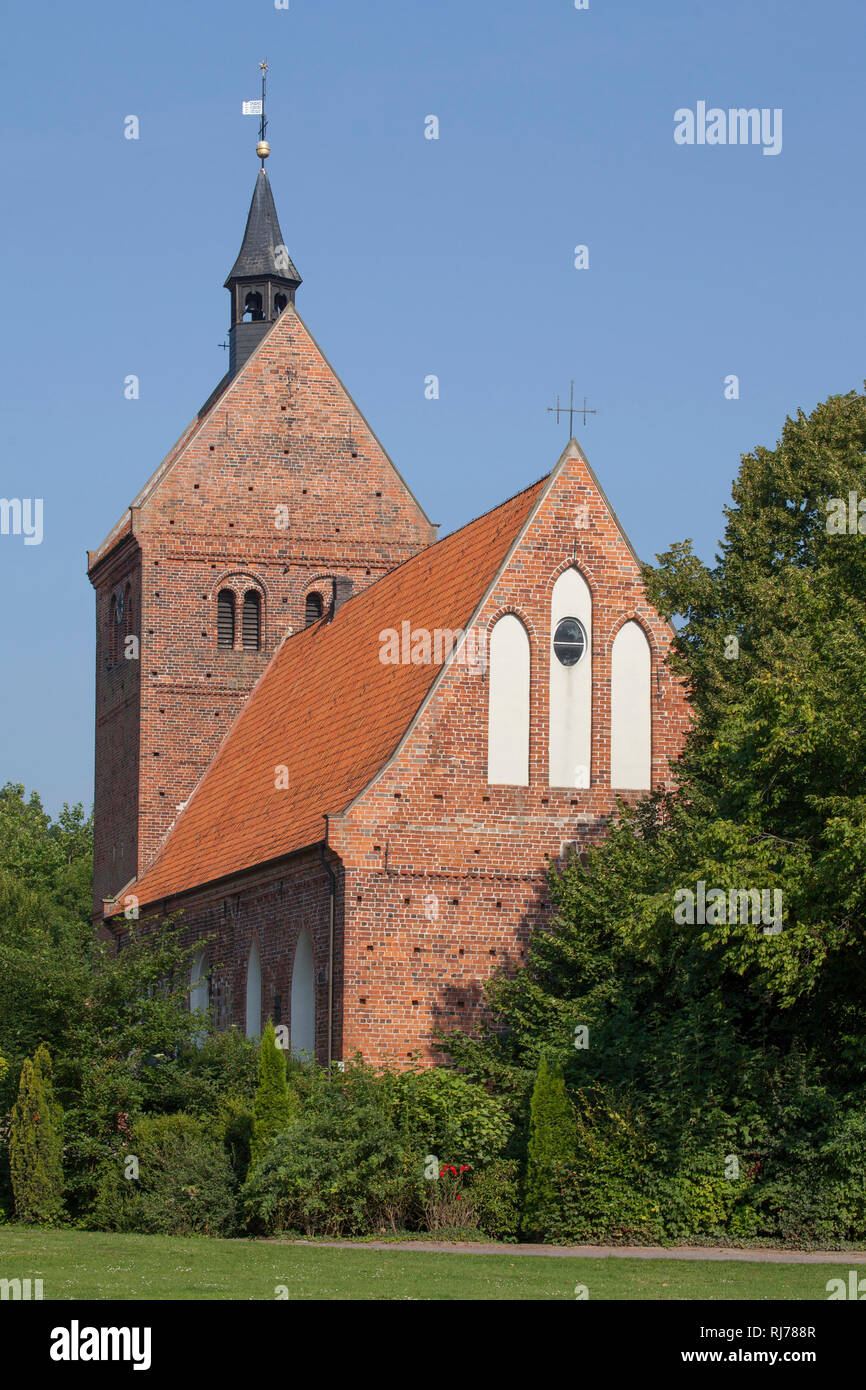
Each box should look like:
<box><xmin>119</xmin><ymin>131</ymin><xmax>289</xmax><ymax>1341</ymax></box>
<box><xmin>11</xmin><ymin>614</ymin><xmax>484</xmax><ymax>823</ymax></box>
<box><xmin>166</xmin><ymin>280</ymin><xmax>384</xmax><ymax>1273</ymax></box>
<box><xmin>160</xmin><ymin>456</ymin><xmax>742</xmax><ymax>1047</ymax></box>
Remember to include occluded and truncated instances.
<box><xmin>10</xmin><ymin>1043</ymin><xmax>63</xmax><ymax>1223</ymax></box>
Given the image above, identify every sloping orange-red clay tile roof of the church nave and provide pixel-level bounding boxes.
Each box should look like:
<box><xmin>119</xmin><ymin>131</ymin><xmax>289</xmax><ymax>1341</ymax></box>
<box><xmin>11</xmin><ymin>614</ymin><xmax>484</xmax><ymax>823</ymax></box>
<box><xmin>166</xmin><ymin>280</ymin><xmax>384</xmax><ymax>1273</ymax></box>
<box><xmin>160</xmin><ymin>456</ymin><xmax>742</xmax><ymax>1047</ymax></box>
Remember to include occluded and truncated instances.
<box><xmin>113</xmin><ymin>478</ymin><xmax>548</xmax><ymax>915</ymax></box>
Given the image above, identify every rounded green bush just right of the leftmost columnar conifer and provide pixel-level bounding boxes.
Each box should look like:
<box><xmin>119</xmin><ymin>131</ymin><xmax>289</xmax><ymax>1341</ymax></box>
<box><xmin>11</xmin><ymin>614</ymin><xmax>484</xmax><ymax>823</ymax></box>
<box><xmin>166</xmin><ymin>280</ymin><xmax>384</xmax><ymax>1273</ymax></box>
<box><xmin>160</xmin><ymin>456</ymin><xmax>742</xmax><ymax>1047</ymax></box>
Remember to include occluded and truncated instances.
<box><xmin>89</xmin><ymin>1113</ymin><xmax>238</xmax><ymax>1236</ymax></box>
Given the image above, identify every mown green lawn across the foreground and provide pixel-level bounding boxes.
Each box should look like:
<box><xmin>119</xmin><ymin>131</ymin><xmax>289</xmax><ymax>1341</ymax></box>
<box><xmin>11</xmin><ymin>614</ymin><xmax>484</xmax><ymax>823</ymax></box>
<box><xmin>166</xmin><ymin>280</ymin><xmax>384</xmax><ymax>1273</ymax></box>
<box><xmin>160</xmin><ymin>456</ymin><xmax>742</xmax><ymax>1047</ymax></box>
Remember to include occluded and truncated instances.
<box><xmin>0</xmin><ymin>1226</ymin><xmax>850</xmax><ymax>1301</ymax></box>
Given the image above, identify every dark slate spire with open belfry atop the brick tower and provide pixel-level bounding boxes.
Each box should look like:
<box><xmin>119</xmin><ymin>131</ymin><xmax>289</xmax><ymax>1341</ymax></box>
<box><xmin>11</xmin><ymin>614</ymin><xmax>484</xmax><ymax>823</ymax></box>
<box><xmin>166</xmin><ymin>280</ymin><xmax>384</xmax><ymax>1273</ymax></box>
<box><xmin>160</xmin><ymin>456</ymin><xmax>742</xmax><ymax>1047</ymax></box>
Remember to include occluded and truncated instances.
<box><xmin>225</xmin><ymin>170</ymin><xmax>300</xmax><ymax>377</ymax></box>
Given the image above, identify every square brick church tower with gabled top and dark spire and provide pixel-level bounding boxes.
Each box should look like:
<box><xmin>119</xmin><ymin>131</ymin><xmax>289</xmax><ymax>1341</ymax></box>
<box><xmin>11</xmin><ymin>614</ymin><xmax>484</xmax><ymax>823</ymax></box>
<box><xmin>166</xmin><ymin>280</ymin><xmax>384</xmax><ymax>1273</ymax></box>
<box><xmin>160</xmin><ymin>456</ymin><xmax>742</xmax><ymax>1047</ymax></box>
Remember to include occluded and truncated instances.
<box><xmin>88</xmin><ymin>122</ymin><xmax>436</xmax><ymax>920</ymax></box>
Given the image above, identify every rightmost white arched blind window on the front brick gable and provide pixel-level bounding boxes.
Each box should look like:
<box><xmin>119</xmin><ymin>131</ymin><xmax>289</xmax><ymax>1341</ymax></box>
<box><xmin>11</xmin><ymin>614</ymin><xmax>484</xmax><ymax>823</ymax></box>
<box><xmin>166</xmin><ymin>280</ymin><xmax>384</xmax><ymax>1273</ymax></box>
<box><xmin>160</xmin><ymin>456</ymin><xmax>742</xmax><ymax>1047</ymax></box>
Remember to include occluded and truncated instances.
<box><xmin>610</xmin><ymin>621</ymin><xmax>652</xmax><ymax>791</ymax></box>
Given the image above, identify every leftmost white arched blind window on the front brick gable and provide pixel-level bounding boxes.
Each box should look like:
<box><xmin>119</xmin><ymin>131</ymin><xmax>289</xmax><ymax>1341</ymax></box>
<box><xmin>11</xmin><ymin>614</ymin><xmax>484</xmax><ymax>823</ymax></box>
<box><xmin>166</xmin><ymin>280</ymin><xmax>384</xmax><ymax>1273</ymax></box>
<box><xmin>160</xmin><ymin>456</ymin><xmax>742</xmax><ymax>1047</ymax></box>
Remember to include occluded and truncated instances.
<box><xmin>487</xmin><ymin>613</ymin><xmax>530</xmax><ymax>787</ymax></box>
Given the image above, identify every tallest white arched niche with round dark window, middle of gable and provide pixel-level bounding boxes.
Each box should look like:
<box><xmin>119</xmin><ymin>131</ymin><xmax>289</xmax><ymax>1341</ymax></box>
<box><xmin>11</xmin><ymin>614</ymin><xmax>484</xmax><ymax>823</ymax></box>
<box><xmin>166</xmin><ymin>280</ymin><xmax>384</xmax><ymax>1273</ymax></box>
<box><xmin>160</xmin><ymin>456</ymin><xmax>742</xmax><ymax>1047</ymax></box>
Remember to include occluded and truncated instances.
<box><xmin>549</xmin><ymin>569</ymin><xmax>592</xmax><ymax>787</ymax></box>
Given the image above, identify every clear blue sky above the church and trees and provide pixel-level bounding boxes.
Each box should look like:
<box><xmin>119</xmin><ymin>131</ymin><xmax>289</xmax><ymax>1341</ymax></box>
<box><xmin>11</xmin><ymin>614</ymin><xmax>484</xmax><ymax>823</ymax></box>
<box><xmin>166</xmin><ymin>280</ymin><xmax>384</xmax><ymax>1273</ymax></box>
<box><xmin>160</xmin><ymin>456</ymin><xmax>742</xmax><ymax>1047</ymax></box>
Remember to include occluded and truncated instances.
<box><xmin>0</xmin><ymin>0</ymin><xmax>866</xmax><ymax>810</ymax></box>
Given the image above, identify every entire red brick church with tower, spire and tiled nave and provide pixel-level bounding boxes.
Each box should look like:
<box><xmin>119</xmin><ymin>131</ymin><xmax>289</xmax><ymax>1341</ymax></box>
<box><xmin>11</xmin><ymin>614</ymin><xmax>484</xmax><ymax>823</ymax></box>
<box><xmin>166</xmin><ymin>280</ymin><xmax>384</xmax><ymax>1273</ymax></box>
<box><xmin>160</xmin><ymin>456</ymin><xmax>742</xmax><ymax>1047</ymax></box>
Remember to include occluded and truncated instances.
<box><xmin>88</xmin><ymin>147</ymin><xmax>688</xmax><ymax>1065</ymax></box>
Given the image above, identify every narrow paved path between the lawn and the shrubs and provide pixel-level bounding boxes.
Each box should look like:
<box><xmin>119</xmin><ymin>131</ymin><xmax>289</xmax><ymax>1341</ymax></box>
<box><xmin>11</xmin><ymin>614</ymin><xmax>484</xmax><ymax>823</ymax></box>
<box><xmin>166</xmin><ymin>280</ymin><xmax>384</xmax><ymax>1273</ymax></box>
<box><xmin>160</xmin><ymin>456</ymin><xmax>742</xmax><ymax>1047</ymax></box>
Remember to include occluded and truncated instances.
<box><xmin>274</xmin><ymin>1240</ymin><xmax>866</xmax><ymax>1268</ymax></box>
